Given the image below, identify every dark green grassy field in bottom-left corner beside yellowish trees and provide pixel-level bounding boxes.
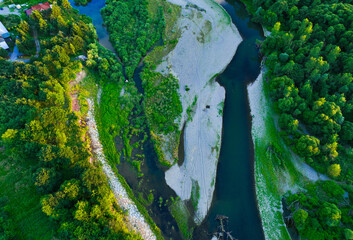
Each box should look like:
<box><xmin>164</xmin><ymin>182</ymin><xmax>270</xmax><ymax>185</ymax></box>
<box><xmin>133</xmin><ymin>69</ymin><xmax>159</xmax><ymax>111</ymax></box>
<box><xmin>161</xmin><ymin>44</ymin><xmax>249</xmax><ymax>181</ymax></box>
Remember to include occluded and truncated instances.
<box><xmin>0</xmin><ymin>153</ymin><xmax>57</xmax><ymax>240</ymax></box>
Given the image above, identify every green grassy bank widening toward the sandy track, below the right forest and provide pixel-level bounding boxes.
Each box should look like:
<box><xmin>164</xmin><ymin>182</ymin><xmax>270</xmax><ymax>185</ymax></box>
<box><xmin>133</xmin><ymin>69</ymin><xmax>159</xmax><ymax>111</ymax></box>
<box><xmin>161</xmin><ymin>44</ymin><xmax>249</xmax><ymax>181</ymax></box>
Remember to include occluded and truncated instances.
<box><xmin>252</xmin><ymin>74</ymin><xmax>303</xmax><ymax>240</ymax></box>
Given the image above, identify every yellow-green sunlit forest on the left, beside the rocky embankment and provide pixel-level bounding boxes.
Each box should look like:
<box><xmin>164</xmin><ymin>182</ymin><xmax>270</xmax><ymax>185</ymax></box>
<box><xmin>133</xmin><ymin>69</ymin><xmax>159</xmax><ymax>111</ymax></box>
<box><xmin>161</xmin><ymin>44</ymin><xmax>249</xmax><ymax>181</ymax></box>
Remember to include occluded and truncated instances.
<box><xmin>0</xmin><ymin>0</ymin><xmax>140</xmax><ymax>239</ymax></box>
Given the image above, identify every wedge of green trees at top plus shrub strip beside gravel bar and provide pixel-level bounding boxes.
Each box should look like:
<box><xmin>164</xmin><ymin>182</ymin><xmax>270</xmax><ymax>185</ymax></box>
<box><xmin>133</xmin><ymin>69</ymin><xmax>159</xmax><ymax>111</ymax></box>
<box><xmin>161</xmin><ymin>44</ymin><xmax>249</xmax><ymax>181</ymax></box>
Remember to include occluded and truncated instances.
<box><xmin>102</xmin><ymin>0</ymin><xmax>182</xmax><ymax>166</ymax></box>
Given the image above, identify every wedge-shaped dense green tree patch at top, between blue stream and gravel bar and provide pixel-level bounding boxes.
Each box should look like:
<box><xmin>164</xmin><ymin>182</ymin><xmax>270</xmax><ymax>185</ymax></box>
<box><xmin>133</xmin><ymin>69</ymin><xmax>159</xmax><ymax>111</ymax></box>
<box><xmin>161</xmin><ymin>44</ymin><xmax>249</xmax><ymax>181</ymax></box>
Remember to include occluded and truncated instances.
<box><xmin>102</xmin><ymin>0</ymin><xmax>165</xmax><ymax>78</ymax></box>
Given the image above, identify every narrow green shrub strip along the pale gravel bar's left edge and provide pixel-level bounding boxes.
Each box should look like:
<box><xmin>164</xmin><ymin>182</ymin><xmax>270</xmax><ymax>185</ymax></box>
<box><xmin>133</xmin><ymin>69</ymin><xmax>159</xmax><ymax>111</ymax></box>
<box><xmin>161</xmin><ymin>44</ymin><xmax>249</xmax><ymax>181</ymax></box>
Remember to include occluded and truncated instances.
<box><xmin>141</xmin><ymin>2</ymin><xmax>182</xmax><ymax>167</ymax></box>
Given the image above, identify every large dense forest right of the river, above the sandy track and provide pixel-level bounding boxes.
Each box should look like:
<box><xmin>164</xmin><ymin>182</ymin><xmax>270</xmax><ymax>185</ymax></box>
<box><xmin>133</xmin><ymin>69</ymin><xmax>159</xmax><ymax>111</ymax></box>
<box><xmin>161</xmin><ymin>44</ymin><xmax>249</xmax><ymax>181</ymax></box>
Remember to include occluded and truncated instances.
<box><xmin>254</xmin><ymin>0</ymin><xmax>353</xmax><ymax>182</ymax></box>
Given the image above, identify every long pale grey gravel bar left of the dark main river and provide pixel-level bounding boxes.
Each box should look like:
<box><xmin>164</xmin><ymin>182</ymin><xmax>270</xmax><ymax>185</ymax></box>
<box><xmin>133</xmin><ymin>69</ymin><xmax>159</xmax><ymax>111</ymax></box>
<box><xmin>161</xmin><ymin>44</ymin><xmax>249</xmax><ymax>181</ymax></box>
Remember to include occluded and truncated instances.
<box><xmin>156</xmin><ymin>0</ymin><xmax>242</xmax><ymax>224</ymax></box>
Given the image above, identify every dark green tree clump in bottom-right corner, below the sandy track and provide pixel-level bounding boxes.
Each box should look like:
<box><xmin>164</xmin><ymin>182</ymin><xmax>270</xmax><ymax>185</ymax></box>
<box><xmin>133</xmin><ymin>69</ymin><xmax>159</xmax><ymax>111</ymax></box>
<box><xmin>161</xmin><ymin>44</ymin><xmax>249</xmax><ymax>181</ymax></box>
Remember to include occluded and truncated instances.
<box><xmin>287</xmin><ymin>181</ymin><xmax>352</xmax><ymax>240</ymax></box>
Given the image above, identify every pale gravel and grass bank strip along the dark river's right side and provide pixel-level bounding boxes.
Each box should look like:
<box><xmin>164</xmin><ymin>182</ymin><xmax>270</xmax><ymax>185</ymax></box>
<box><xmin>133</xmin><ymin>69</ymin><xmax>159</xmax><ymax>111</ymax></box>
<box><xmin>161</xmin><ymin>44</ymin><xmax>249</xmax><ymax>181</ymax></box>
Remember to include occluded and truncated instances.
<box><xmin>247</xmin><ymin>69</ymin><xmax>294</xmax><ymax>240</ymax></box>
